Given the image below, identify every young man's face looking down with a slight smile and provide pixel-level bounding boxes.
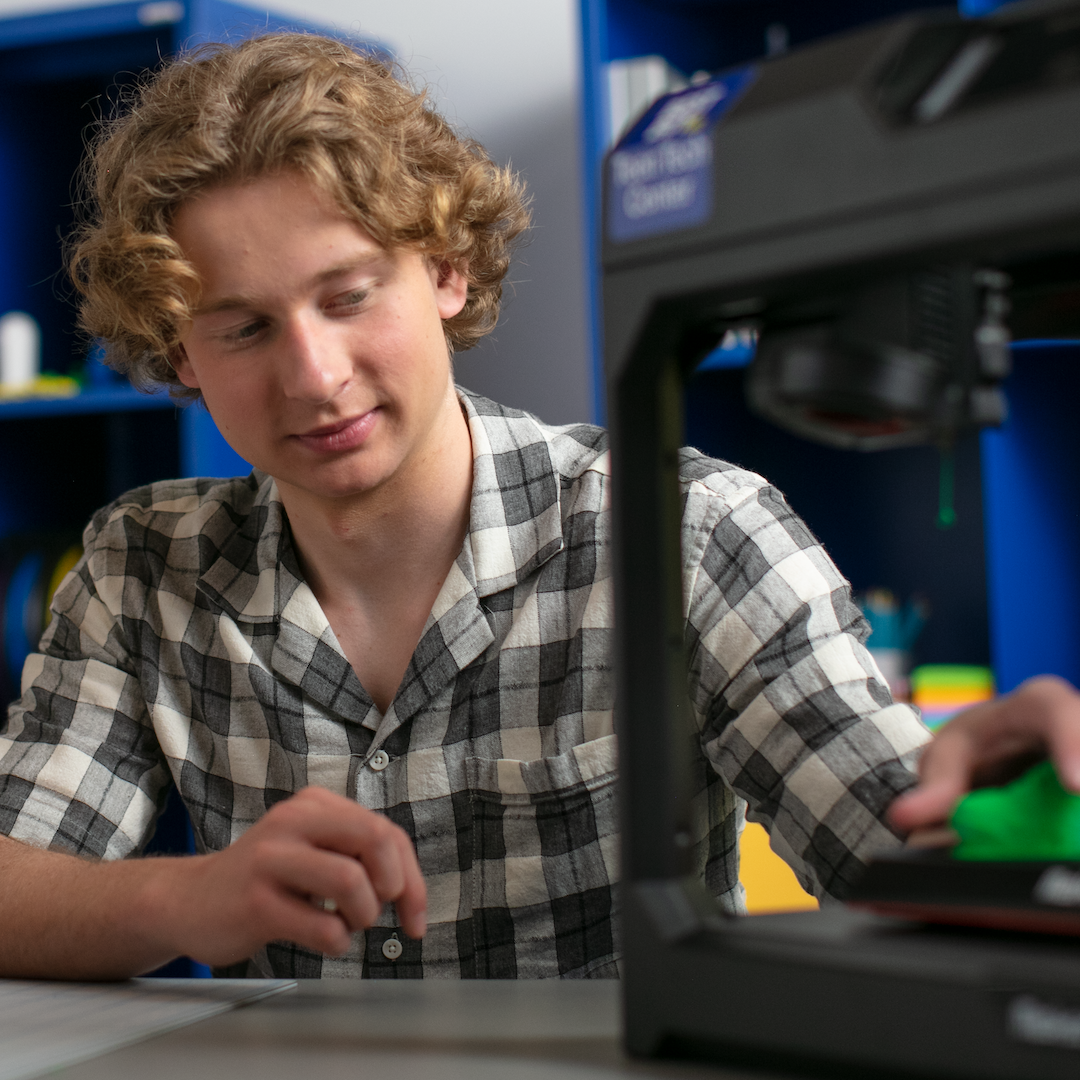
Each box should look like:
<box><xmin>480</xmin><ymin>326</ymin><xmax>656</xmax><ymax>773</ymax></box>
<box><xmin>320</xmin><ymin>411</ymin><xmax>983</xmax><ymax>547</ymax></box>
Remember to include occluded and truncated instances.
<box><xmin>172</xmin><ymin>173</ymin><xmax>467</xmax><ymax>499</ymax></box>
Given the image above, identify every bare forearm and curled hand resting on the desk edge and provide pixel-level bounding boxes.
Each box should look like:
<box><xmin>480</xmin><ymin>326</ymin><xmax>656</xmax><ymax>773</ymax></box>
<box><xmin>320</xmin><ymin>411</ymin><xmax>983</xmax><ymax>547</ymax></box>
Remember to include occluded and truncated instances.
<box><xmin>0</xmin><ymin>787</ymin><xmax>427</xmax><ymax>978</ymax></box>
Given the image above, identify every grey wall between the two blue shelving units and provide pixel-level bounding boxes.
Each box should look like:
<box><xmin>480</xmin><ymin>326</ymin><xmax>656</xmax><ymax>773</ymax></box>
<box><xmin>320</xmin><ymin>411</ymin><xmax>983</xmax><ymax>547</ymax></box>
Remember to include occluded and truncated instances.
<box><xmin>0</xmin><ymin>0</ymin><xmax>595</xmax><ymax>423</ymax></box>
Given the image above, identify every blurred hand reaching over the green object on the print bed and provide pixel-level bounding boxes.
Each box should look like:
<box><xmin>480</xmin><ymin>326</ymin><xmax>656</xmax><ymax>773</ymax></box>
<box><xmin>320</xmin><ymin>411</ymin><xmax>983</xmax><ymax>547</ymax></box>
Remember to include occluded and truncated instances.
<box><xmin>889</xmin><ymin>675</ymin><xmax>1080</xmax><ymax>833</ymax></box>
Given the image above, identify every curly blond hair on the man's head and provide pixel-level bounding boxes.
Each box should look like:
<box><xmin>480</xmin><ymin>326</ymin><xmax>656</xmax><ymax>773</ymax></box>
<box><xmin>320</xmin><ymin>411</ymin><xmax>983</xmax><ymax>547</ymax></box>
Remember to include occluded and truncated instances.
<box><xmin>68</xmin><ymin>33</ymin><xmax>529</xmax><ymax>399</ymax></box>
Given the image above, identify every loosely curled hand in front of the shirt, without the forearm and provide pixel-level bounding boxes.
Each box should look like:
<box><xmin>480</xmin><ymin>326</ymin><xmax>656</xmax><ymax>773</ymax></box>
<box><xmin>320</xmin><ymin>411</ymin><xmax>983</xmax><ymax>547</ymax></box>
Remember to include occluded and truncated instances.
<box><xmin>161</xmin><ymin>787</ymin><xmax>427</xmax><ymax>964</ymax></box>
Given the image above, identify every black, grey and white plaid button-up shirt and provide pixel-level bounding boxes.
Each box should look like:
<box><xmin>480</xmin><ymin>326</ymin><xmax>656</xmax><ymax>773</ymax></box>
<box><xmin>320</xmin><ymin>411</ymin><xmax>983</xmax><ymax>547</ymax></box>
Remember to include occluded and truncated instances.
<box><xmin>0</xmin><ymin>393</ymin><xmax>926</xmax><ymax>977</ymax></box>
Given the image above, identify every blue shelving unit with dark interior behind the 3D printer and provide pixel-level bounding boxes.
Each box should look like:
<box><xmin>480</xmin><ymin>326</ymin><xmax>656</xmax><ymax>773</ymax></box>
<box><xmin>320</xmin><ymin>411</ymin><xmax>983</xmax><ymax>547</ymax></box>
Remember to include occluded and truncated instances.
<box><xmin>581</xmin><ymin>0</ymin><xmax>1080</xmax><ymax>690</ymax></box>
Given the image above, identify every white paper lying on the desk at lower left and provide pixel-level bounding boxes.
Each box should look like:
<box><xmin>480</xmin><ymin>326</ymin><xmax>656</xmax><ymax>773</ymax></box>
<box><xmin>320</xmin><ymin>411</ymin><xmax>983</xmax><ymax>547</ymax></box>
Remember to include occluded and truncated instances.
<box><xmin>0</xmin><ymin>978</ymin><xmax>295</xmax><ymax>1080</ymax></box>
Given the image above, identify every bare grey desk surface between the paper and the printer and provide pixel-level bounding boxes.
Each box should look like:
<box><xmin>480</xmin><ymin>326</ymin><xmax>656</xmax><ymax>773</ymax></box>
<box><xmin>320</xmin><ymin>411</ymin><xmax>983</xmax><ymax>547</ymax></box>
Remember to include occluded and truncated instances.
<box><xmin>51</xmin><ymin>980</ymin><xmax>786</xmax><ymax>1080</ymax></box>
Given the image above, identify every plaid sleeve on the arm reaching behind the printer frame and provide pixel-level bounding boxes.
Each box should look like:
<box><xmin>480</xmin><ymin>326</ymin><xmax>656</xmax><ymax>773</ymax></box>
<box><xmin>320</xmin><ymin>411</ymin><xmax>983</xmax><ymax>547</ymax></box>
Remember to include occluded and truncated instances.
<box><xmin>683</xmin><ymin>451</ymin><xmax>930</xmax><ymax>896</ymax></box>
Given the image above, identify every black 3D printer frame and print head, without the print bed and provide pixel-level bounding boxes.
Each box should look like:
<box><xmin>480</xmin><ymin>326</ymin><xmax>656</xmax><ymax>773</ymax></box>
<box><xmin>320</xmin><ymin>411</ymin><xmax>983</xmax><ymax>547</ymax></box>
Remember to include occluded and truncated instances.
<box><xmin>604</xmin><ymin>0</ymin><xmax>1080</xmax><ymax>1080</ymax></box>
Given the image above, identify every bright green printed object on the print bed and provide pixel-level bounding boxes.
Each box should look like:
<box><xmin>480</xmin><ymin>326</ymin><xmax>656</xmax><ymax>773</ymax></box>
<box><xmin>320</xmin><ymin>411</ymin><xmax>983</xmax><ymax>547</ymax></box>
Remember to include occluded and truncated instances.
<box><xmin>950</xmin><ymin>761</ymin><xmax>1080</xmax><ymax>862</ymax></box>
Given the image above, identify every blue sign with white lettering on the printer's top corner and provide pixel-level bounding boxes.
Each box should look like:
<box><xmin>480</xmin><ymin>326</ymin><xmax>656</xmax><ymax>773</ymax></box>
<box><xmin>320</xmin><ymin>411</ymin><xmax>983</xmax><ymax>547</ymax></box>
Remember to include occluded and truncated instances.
<box><xmin>607</xmin><ymin>67</ymin><xmax>754</xmax><ymax>241</ymax></box>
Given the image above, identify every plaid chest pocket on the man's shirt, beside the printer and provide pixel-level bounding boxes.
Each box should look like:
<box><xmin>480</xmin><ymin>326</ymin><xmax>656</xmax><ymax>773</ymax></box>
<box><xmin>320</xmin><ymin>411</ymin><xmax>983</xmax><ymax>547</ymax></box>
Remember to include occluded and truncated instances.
<box><xmin>465</xmin><ymin>734</ymin><xmax>619</xmax><ymax>978</ymax></box>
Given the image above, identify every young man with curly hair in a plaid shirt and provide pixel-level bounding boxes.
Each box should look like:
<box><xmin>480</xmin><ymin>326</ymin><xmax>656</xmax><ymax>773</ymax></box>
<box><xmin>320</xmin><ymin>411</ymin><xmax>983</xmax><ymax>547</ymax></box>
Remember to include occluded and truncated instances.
<box><xmin>0</xmin><ymin>36</ymin><xmax>1080</xmax><ymax>977</ymax></box>
